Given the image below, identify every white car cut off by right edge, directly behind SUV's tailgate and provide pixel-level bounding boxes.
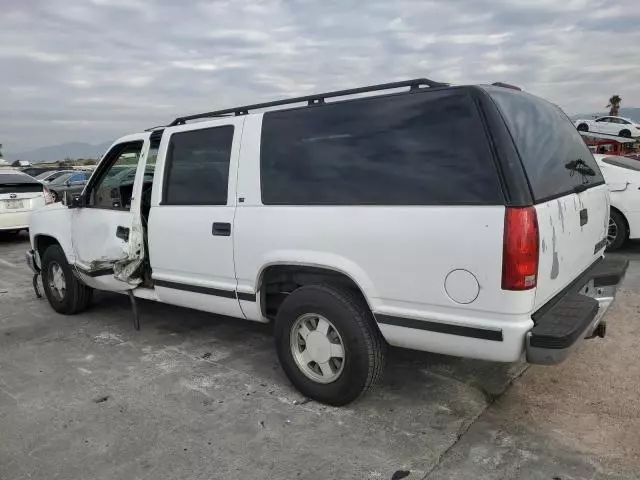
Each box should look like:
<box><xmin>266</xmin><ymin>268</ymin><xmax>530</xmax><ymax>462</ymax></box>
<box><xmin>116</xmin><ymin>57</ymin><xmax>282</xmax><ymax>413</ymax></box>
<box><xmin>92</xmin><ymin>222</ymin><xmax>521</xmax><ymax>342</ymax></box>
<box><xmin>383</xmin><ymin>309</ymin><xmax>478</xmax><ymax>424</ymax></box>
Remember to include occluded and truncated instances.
<box><xmin>594</xmin><ymin>155</ymin><xmax>640</xmax><ymax>250</ymax></box>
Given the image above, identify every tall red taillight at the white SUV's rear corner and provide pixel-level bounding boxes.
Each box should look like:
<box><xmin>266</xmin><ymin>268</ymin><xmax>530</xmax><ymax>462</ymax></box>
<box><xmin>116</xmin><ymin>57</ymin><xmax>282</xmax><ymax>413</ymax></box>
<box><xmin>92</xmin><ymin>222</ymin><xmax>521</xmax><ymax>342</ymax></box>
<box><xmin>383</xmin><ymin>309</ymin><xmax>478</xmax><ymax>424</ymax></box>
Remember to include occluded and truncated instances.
<box><xmin>502</xmin><ymin>207</ymin><xmax>539</xmax><ymax>290</ymax></box>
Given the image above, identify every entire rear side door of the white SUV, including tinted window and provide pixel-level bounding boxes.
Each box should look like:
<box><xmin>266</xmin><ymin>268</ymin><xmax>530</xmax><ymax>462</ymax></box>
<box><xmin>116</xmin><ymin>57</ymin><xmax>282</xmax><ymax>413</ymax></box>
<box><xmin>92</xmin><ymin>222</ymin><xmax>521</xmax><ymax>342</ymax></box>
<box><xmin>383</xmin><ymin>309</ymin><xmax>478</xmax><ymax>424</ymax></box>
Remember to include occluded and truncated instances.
<box><xmin>148</xmin><ymin>118</ymin><xmax>244</xmax><ymax>317</ymax></box>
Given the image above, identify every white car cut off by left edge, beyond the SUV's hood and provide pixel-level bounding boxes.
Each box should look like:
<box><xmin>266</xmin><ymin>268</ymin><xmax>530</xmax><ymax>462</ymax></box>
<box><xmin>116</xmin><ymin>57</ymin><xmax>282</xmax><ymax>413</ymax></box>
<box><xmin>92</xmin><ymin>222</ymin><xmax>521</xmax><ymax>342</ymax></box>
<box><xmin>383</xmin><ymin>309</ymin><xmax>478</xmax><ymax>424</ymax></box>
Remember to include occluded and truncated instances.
<box><xmin>0</xmin><ymin>169</ymin><xmax>48</xmax><ymax>232</ymax></box>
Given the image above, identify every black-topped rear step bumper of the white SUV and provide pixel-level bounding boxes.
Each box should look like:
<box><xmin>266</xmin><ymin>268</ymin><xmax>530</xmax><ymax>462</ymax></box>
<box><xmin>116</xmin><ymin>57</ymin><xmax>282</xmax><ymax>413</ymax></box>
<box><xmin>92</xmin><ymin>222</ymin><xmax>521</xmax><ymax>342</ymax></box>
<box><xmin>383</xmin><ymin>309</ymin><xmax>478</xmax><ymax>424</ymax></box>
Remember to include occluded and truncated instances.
<box><xmin>526</xmin><ymin>258</ymin><xmax>629</xmax><ymax>365</ymax></box>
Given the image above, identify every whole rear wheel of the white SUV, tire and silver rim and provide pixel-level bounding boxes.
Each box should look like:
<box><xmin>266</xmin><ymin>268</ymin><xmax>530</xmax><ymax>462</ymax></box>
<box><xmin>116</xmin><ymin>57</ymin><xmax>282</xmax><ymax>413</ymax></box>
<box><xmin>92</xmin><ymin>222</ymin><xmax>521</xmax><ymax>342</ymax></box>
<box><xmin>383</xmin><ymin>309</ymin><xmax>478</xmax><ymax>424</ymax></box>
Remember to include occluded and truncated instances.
<box><xmin>275</xmin><ymin>285</ymin><xmax>386</xmax><ymax>406</ymax></box>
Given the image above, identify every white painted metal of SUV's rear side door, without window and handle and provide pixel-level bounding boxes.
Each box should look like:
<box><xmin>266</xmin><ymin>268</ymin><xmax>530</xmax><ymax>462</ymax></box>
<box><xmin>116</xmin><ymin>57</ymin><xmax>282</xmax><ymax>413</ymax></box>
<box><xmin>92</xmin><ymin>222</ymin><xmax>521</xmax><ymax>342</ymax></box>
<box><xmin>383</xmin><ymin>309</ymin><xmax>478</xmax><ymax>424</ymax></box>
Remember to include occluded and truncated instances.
<box><xmin>149</xmin><ymin>117</ymin><xmax>244</xmax><ymax>318</ymax></box>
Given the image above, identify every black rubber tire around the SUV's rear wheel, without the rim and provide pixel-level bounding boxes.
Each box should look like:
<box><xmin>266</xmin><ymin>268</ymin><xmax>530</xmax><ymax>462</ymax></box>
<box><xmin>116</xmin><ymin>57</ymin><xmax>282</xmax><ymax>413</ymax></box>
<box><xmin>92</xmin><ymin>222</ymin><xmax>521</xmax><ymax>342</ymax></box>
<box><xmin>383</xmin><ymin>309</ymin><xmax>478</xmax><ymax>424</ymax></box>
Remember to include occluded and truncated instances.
<box><xmin>275</xmin><ymin>284</ymin><xmax>387</xmax><ymax>406</ymax></box>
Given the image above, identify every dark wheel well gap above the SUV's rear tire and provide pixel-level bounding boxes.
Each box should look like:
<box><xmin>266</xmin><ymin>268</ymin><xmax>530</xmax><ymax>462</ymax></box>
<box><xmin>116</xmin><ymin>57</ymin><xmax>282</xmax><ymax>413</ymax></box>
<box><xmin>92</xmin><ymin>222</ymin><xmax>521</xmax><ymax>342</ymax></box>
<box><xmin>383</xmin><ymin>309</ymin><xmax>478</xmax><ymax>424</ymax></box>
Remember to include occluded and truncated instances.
<box><xmin>258</xmin><ymin>265</ymin><xmax>368</xmax><ymax>319</ymax></box>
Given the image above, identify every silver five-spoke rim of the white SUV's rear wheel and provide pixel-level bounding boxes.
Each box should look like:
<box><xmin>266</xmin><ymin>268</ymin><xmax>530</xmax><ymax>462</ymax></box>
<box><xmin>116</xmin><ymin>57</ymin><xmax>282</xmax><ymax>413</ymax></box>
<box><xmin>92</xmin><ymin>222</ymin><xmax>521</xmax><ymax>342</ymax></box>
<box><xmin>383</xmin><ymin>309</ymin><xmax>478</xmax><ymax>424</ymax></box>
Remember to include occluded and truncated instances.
<box><xmin>290</xmin><ymin>313</ymin><xmax>345</xmax><ymax>383</ymax></box>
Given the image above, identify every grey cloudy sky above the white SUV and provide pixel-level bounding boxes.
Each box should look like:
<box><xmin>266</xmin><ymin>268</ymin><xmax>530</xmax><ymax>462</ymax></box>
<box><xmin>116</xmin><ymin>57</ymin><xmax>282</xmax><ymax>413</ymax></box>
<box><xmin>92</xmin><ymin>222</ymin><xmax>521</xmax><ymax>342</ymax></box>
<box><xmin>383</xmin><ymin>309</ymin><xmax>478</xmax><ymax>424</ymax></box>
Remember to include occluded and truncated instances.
<box><xmin>0</xmin><ymin>0</ymin><xmax>640</xmax><ymax>152</ymax></box>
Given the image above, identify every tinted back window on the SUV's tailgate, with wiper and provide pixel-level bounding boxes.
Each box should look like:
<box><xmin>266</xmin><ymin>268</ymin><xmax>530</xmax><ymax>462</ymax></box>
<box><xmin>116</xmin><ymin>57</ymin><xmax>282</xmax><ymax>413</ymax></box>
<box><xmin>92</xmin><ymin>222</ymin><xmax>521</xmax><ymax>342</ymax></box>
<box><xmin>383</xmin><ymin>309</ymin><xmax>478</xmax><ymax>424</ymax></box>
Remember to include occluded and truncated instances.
<box><xmin>487</xmin><ymin>88</ymin><xmax>604</xmax><ymax>202</ymax></box>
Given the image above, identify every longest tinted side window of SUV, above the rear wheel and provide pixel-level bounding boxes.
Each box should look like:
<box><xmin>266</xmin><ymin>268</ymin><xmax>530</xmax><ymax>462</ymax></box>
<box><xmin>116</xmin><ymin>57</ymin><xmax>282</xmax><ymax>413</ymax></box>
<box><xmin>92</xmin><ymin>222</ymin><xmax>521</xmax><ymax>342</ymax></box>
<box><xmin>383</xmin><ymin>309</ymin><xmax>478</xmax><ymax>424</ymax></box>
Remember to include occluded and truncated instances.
<box><xmin>261</xmin><ymin>89</ymin><xmax>503</xmax><ymax>205</ymax></box>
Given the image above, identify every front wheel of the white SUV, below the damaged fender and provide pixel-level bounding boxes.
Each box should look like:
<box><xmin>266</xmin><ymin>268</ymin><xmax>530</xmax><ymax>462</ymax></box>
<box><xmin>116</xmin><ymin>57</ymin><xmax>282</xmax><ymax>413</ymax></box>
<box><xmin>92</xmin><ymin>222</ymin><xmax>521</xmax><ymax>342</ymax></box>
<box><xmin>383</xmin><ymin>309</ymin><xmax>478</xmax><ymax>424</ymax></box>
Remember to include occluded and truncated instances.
<box><xmin>42</xmin><ymin>245</ymin><xmax>93</xmax><ymax>315</ymax></box>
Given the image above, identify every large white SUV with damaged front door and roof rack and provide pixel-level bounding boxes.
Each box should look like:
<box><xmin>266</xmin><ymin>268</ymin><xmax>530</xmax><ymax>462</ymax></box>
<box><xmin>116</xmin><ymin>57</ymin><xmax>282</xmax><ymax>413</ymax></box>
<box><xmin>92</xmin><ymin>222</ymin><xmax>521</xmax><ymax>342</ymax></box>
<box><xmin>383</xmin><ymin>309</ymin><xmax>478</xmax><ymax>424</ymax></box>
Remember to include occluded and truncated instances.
<box><xmin>27</xmin><ymin>79</ymin><xmax>626</xmax><ymax>405</ymax></box>
